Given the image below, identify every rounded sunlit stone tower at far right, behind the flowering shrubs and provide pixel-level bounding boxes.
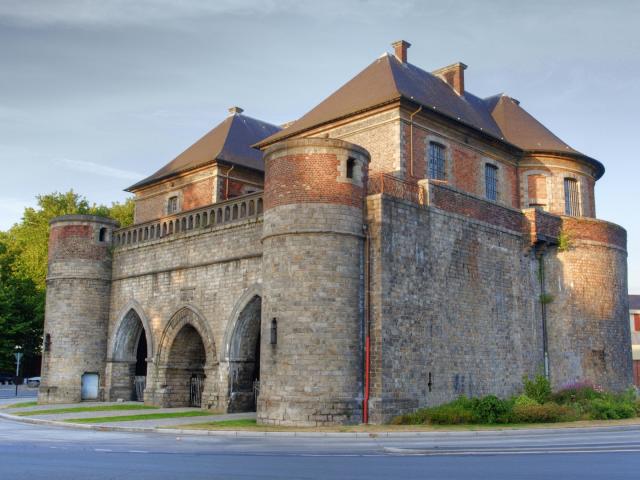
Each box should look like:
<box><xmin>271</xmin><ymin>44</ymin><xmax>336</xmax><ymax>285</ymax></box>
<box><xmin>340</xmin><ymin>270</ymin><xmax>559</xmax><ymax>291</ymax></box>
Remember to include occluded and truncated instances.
<box><xmin>543</xmin><ymin>221</ymin><xmax>633</xmax><ymax>391</ymax></box>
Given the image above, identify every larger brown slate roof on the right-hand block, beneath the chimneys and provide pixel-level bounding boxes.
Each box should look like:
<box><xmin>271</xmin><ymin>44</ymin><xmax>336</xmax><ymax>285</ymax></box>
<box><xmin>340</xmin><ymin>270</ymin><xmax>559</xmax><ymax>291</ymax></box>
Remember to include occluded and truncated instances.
<box><xmin>256</xmin><ymin>54</ymin><xmax>604</xmax><ymax>178</ymax></box>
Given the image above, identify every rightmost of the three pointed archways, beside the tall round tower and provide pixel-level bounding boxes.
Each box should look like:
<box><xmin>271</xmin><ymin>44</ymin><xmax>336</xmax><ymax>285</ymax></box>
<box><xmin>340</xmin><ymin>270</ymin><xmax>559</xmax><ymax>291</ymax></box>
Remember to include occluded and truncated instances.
<box><xmin>227</xmin><ymin>295</ymin><xmax>262</xmax><ymax>412</ymax></box>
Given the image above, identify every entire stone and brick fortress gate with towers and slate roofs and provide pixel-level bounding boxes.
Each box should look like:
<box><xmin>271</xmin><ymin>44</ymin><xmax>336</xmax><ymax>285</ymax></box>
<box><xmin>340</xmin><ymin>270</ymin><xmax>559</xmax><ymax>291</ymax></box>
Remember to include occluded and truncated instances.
<box><xmin>39</xmin><ymin>41</ymin><xmax>631</xmax><ymax>425</ymax></box>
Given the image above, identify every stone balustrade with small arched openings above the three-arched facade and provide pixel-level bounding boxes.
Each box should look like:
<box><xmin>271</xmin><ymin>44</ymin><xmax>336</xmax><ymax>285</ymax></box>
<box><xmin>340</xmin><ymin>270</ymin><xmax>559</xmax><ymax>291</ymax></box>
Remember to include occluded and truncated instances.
<box><xmin>113</xmin><ymin>192</ymin><xmax>263</xmax><ymax>247</ymax></box>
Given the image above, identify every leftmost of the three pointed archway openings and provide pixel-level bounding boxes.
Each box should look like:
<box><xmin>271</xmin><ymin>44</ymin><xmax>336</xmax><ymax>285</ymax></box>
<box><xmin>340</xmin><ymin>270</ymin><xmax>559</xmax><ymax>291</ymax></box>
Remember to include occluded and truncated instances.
<box><xmin>109</xmin><ymin>308</ymin><xmax>151</xmax><ymax>401</ymax></box>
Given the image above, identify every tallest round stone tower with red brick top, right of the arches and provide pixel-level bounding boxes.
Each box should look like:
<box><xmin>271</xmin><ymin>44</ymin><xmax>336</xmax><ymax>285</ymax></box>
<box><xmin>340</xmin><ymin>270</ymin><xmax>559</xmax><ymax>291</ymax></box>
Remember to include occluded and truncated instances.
<box><xmin>257</xmin><ymin>138</ymin><xmax>369</xmax><ymax>425</ymax></box>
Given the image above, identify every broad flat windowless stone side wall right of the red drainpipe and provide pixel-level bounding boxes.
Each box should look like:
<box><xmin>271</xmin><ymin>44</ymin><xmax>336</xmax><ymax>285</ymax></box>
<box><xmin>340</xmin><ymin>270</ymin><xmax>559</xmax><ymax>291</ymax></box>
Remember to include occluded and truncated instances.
<box><xmin>367</xmin><ymin>196</ymin><xmax>543</xmax><ymax>422</ymax></box>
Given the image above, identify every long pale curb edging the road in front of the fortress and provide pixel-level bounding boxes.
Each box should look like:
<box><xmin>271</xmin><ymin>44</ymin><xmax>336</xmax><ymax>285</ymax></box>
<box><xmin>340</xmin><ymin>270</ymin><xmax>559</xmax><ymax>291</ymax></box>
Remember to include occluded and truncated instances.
<box><xmin>0</xmin><ymin>413</ymin><xmax>640</xmax><ymax>438</ymax></box>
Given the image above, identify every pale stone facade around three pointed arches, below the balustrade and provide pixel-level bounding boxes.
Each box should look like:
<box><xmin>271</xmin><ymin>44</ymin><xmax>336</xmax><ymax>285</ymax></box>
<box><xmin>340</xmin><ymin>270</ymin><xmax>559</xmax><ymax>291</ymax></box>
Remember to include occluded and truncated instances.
<box><xmin>108</xmin><ymin>218</ymin><xmax>262</xmax><ymax>409</ymax></box>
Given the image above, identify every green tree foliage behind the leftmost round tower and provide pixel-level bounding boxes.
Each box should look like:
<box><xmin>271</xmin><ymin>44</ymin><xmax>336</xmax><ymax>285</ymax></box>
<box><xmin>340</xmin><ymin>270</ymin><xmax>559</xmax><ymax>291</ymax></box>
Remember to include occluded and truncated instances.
<box><xmin>0</xmin><ymin>190</ymin><xmax>134</xmax><ymax>371</ymax></box>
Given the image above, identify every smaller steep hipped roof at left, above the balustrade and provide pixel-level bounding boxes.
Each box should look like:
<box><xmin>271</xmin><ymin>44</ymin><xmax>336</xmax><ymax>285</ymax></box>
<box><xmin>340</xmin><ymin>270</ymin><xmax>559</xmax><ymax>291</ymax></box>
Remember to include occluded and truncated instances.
<box><xmin>126</xmin><ymin>109</ymin><xmax>280</xmax><ymax>191</ymax></box>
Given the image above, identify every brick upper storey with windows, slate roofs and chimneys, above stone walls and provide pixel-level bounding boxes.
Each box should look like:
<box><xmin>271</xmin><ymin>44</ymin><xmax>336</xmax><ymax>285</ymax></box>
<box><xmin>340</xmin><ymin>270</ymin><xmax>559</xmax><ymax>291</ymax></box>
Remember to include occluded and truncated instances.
<box><xmin>129</xmin><ymin>42</ymin><xmax>604</xmax><ymax>227</ymax></box>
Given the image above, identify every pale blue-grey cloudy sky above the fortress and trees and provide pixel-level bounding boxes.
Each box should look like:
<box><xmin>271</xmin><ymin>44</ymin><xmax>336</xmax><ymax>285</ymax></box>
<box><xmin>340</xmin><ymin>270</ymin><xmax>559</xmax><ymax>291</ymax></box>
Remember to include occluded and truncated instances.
<box><xmin>0</xmin><ymin>0</ymin><xmax>640</xmax><ymax>294</ymax></box>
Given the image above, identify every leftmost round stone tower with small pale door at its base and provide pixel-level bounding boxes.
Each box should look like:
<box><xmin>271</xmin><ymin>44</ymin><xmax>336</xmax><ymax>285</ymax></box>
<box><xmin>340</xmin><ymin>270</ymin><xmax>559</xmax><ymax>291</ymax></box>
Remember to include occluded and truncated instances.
<box><xmin>38</xmin><ymin>215</ymin><xmax>118</xmax><ymax>403</ymax></box>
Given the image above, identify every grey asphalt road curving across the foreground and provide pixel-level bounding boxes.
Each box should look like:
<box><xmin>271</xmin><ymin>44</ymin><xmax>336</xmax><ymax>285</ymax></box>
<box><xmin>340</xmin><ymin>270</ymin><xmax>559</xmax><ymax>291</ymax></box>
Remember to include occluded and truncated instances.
<box><xmin>0</xmin><ymin>419</ymin><xmax>640</xmax><ymax>480</ymax></box>
